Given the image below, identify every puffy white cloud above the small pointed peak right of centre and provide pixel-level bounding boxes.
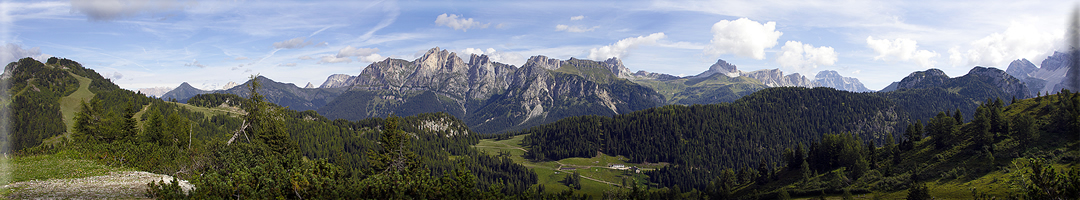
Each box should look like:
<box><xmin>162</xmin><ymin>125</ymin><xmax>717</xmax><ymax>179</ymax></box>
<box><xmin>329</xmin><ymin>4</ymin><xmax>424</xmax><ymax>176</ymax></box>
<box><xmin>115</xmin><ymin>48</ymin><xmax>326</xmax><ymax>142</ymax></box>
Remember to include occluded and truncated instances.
<box><xmin>704</xmin><ymin>18</ymin><xmax>784</xmax><ymax>59</ymax></box>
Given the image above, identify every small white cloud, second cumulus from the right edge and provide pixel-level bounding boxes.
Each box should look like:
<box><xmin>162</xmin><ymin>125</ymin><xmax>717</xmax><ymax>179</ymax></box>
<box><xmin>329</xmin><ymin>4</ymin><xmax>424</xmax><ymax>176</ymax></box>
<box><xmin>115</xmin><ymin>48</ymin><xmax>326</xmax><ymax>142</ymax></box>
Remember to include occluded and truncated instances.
<box><xmin>866</xmin><ymin>36</ymin><xmax>941</xmax><ymax>68</ymax></box>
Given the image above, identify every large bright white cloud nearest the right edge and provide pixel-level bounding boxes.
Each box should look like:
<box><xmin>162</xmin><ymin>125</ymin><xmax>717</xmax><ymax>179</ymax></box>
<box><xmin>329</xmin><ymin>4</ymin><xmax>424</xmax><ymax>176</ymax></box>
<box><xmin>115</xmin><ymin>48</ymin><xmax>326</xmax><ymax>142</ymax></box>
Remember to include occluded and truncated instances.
<box><xmin>949</xmin><ymin>23</ymin><xmax>1065</xmax><ymax>66</ymax></box>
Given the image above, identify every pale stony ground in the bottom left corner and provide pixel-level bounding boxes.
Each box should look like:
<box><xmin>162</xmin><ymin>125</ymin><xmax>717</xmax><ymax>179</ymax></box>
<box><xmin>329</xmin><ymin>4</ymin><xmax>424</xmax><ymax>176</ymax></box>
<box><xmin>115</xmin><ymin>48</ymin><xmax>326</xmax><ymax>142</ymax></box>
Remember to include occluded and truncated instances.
<box><xmin>3</xmin><ymin>171</ymin><xmax>192</xmax><ymax>199</ymax></box>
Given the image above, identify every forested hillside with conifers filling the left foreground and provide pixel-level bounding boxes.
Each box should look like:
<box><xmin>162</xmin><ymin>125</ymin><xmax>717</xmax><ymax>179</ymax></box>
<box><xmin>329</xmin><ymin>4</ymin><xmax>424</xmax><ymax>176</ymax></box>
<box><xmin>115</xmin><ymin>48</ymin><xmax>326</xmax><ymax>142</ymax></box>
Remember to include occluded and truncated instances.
<box><xmin>4</xmin><ymin>58</ymin><xmax>557</xmax><ymax>198</ymax></box>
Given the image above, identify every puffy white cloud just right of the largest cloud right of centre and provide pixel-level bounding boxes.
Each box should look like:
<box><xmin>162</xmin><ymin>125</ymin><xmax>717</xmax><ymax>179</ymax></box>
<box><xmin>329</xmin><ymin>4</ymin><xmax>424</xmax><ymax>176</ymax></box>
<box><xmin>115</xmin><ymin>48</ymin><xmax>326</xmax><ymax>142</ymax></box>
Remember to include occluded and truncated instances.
<box><xmin>777</xmin><ymin>41</ymin><xmax>837</xmax><ymax>75</ymax></box>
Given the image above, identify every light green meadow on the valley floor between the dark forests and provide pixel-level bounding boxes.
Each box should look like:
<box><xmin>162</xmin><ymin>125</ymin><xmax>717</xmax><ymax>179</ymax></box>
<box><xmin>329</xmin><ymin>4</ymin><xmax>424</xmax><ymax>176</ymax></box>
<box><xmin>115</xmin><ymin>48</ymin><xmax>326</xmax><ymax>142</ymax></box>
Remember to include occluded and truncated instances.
<box><xmin>474</xmin><ymin>135</ymin><xmax>665</xmax><ymax>198</ymax></box>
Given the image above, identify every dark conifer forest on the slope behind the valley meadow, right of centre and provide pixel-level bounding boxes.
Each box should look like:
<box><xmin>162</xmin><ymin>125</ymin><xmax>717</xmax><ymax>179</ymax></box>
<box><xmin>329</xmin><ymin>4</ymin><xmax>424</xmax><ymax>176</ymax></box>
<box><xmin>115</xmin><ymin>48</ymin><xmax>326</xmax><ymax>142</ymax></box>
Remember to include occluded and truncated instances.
<box><xmin>523</xmin><ymin>88</ymin><xmax>889</xmax><ymax>189</ymax></box>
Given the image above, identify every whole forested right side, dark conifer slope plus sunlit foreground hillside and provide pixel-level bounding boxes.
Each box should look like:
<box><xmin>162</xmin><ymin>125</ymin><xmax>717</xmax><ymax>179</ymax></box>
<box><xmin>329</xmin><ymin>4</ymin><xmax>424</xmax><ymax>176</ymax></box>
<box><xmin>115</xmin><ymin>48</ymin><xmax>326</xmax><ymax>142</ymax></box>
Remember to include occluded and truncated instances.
<box><xmin>515</xmin><ymin>84</ymin><xmax>1080</xmax><ymax>199</ymax></box>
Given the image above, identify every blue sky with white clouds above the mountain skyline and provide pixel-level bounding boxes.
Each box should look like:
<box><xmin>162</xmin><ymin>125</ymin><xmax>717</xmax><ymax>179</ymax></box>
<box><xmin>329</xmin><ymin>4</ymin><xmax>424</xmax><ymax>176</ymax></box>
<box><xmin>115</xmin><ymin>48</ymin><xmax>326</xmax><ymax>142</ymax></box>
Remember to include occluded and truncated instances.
<box><xmin>0</xmin><ymin>0</ymin><xmax>1078</xmax><ymax>90</ymax></box>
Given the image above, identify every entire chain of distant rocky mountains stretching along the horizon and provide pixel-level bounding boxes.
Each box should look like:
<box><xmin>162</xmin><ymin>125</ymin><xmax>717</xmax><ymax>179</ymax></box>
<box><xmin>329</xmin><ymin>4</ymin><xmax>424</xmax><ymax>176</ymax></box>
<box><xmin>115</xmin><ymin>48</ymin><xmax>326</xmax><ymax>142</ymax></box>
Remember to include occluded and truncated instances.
<box><xmin>161</xmin><ymin>48</ymin><xmax>1049</xmax><ymax>133</ymax></box>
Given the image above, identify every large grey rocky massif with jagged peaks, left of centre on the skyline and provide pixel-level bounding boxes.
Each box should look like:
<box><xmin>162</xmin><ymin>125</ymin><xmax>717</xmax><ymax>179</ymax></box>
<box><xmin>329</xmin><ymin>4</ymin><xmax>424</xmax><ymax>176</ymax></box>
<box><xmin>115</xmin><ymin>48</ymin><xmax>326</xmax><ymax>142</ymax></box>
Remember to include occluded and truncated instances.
<box><xmin>319</xmin><ymin>48</ymin><xmax>663</xmax><ymax>133</ymax></box>
